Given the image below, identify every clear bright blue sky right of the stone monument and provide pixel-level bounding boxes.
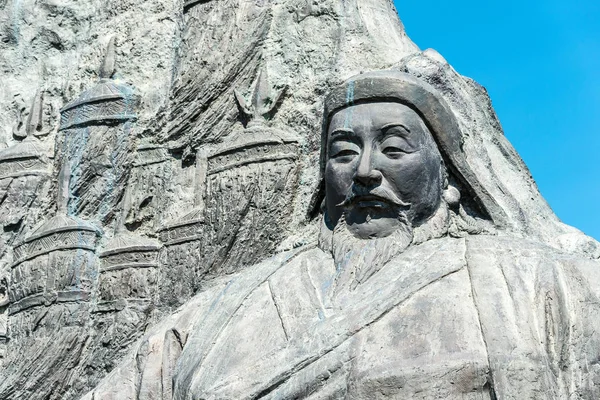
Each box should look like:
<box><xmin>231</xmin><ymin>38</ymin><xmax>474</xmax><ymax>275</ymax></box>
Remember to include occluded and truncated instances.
<box><xmin>394</xmin><ymin>0</ymin><xmax>600</xmax><ymax>239</ymax></box>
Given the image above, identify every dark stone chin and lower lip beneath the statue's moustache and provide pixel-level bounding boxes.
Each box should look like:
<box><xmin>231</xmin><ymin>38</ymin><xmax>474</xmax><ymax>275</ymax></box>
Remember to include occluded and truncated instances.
<box><xmin>345</xmin><ymin>208</ymin><xmax>406</xmax><ymax>239</ymax></box>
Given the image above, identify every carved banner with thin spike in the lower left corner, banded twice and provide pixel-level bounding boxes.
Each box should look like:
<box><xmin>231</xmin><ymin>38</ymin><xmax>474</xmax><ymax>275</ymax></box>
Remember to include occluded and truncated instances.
<box><xmin>3</xmin><ymin>165</ymin><xmax>101</xmax><ymax>395</ymax></box>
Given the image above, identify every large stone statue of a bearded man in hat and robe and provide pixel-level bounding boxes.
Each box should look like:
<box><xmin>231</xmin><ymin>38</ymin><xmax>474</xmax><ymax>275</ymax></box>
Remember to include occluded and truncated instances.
<box><xmin>85</xmin><ymin>70</ymin><xmax>600</xmax><ymax>400</ymax></box>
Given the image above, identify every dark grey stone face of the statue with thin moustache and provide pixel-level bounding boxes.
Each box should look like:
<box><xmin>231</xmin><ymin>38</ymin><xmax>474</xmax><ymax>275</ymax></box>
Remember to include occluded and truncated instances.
<box><xmin>325</xmin><ymin>102</ymin><xmax>442</xmax><ymax>239</ymax></box>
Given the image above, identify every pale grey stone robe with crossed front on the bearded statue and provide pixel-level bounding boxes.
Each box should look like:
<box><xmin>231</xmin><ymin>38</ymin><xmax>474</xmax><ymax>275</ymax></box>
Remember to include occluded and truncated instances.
<box><xmin>82</xmin><ymin>236</ymin><xmax>600</xmax><ymax>400</ymax></box>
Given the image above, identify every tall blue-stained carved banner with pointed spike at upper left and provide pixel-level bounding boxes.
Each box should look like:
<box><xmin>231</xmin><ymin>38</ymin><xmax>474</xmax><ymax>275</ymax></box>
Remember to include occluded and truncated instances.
<box><xmin>57</xmin><ymin>41</ymin><xmax>139</xmax><ymax>223</ymax></box>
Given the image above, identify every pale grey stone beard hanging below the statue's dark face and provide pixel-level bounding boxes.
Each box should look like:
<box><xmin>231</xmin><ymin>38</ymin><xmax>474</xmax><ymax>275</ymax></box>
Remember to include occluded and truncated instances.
<box><xmin>319</xmin><ymin>211</ymin><xmax>413</xmax><ymax>297</ymax></box>
